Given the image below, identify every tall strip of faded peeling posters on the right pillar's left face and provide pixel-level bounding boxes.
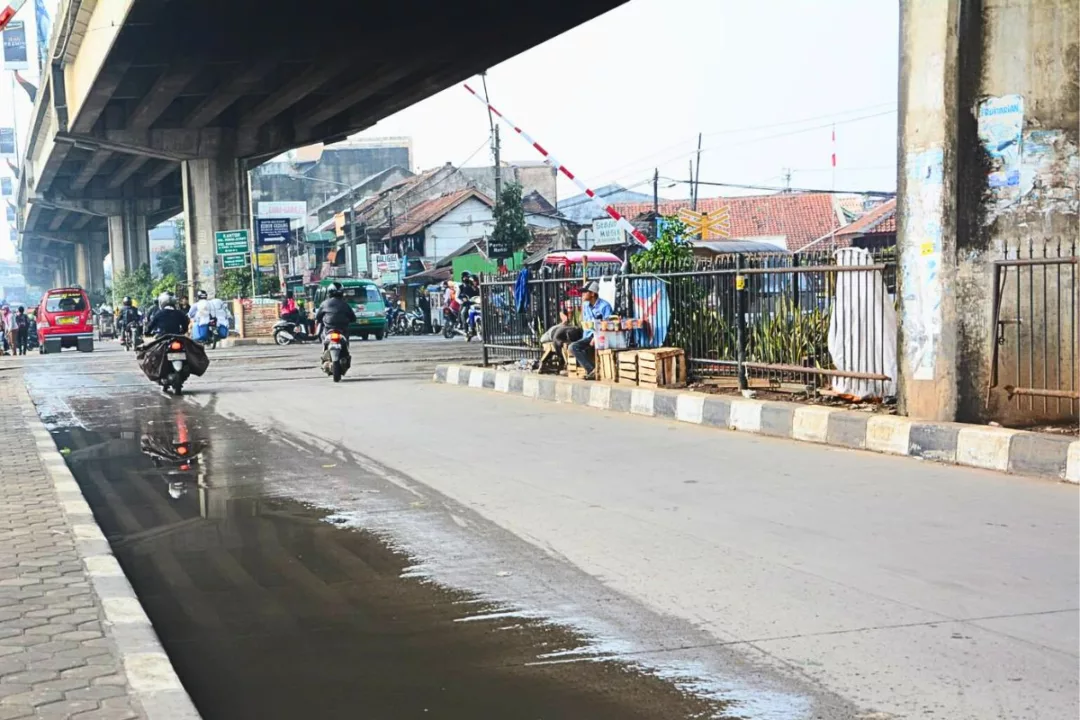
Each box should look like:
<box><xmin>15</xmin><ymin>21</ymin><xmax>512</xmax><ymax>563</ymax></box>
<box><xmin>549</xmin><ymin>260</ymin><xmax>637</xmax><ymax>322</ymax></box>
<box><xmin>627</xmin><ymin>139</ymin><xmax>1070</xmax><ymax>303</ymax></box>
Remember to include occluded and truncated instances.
<box><xmin>900</xmin><ymin>147</ymin><xmax>945</xmax><ymax>380</ymax></box>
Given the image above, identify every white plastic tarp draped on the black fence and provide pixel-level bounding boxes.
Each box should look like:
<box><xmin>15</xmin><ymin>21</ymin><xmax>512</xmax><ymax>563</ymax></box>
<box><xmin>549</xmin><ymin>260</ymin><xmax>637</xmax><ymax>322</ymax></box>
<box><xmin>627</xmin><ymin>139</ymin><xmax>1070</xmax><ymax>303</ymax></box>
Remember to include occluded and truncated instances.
<box><xmin>828</xmin><ymin>247</ymin><xmax>896</xmax><ymax>398</ymax></box>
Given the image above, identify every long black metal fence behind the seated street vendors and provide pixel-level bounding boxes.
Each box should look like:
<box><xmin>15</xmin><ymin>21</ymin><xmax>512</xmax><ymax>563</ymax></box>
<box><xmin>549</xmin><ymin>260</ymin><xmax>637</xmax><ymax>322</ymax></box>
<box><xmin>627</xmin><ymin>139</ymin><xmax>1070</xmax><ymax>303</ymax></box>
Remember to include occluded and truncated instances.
<box><xmin>481</xmin><ymin>248</ymin><xmax>896</xmax><ymax>397</ymax></box>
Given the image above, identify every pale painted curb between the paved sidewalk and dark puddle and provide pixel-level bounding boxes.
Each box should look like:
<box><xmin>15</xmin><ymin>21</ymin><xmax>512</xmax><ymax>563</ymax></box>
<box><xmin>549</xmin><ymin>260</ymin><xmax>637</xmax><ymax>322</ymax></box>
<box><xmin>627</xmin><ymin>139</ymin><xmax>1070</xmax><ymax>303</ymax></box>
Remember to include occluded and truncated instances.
<box><xmin>27</xmin><ymin>412</ymin><xmax>200</xmax><ymax>720</ymax></box>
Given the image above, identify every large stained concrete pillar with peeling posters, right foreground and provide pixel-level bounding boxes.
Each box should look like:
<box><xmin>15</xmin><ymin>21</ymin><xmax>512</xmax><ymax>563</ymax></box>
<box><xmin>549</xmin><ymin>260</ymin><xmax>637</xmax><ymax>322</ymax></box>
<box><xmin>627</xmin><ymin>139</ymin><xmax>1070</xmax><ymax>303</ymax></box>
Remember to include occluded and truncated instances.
<box><xmin>897</xmin><ymin>0</ymin><xmax>1080</xmax><ymax>422</ymax></box>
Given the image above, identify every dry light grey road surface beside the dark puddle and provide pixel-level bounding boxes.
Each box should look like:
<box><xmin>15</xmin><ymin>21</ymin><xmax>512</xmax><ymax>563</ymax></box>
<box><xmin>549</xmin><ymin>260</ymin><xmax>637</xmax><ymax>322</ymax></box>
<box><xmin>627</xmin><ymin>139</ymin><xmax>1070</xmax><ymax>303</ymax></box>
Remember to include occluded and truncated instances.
<box><xmin>12</xmin><ymin>339</ymin><xmax>1080</xmax><ymax>720</ymax></box>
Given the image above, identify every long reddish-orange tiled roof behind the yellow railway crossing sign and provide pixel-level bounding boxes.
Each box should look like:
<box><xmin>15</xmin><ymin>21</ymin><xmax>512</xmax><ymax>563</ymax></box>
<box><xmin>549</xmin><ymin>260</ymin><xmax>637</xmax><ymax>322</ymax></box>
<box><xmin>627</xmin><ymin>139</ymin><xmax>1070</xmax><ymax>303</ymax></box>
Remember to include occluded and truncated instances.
<box><xmin>615</xmin><ymin>192</ymin><xmax>840</xmax><ymax>252</ymax></box>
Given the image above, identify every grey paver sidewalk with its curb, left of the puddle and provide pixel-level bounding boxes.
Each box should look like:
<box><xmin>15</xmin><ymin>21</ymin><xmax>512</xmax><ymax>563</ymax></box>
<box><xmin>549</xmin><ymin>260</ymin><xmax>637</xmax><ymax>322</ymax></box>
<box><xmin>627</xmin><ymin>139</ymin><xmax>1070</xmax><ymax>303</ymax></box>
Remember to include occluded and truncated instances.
<box><xmin>0</xmin><ymin>368</ymin><xmax>199</xmax><ymax>720</ymax></box>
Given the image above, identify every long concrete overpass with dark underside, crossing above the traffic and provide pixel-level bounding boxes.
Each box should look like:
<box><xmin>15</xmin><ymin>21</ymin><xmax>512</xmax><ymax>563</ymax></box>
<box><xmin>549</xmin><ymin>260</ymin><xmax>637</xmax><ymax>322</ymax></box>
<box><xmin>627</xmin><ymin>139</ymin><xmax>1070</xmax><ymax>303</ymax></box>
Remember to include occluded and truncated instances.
<box><xmin>12</xmin><ymin>0</ymin><xmax>625</xmax><ymax>290</ymax></box>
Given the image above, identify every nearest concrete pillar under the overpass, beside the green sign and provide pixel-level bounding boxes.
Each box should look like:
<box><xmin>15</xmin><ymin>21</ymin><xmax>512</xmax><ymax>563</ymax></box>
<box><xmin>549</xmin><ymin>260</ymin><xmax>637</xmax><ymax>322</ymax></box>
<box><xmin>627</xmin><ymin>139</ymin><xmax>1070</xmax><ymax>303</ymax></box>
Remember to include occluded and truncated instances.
<box><xmin>181</xmin><ymin>158</ymin><xmax>251</xmax><ymax>300</ymax></box>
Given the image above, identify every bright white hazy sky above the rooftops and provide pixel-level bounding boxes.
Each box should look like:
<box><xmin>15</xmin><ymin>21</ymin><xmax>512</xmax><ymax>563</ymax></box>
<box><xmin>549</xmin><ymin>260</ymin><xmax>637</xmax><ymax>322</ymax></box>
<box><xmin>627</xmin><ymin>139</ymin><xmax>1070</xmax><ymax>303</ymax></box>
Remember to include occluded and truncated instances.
<box><xmin>0</xmin><ymin>0</ymin><xmax>899</xmax><ymax>257</ymax></box>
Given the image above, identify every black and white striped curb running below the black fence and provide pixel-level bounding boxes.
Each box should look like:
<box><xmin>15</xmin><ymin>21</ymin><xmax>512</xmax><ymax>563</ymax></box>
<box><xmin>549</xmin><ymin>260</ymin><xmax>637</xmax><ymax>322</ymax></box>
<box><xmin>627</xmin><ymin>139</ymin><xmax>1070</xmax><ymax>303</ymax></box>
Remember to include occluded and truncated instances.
<box><xmin>434</xmin><ymin>365</ymin><xmax>1080</xmax><ymax>483</ymax></box>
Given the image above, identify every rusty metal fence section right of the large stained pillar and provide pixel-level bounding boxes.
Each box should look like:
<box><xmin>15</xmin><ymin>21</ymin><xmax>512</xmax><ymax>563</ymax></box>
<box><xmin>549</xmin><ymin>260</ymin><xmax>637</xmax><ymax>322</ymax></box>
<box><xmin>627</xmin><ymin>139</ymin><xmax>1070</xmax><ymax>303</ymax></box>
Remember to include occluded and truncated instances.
<box><xmin>987</xmin><ymin>241</ymin><xmax>1080</xmax><ymax>421</ymax></box>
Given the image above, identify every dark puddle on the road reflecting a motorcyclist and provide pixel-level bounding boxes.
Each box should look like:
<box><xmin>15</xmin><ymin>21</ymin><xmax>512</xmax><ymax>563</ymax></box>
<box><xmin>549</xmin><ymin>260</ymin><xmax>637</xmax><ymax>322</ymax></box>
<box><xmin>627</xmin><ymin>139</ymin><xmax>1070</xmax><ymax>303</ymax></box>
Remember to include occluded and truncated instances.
<box><xmin>40</xmin><ymin>391</ymin><xmax>723</xmax><ymax>720</ymax></box>
